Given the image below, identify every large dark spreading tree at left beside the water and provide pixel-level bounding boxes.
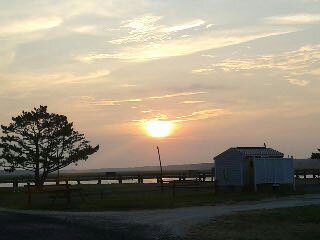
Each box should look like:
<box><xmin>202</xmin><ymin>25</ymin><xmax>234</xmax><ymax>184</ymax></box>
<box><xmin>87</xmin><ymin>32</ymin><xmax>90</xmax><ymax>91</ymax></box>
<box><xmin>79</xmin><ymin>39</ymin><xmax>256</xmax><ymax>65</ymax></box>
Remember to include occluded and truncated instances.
<box><xmin>0</xmin><ymin>106</ymin><xmax>99</xmax><ymax>186</ymax></box>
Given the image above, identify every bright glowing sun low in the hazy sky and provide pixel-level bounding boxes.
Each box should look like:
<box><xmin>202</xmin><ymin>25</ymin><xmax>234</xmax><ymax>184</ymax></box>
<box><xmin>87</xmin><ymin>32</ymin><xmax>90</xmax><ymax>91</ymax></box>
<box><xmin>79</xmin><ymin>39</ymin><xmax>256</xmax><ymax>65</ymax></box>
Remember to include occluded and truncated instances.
<box><xmin>144</xmin><ymin>120</ymin><xmax>174</xmax><ymax>138</ymax></box>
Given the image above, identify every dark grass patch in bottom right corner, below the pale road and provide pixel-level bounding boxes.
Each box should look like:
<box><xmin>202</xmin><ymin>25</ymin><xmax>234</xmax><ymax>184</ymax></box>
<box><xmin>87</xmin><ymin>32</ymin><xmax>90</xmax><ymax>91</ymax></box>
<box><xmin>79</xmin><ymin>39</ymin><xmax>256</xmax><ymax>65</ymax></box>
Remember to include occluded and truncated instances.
<box><xmin>187</xmin><ymin>206</ymin><xmax>320</xmax><ymax>240</ymax></box>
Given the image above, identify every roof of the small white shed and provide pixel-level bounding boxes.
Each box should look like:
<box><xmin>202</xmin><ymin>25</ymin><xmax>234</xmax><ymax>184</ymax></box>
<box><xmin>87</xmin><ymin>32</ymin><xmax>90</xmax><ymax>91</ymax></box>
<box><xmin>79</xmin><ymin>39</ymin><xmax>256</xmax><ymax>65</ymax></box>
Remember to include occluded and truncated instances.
<box><xmin>215</xmin><ymin>147</ymin><xmax>284</xmax><ymax>158</ymax></box>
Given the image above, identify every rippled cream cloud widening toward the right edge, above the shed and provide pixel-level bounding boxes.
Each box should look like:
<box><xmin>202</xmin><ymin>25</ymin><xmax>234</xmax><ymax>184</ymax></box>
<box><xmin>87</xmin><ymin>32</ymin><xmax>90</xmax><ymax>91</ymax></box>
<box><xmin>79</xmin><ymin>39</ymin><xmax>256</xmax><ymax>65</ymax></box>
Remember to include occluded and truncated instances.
<box><xmin>192</xmin><ymin>45</ymin><xmax>320</xmax><ymax>87</ymax></box>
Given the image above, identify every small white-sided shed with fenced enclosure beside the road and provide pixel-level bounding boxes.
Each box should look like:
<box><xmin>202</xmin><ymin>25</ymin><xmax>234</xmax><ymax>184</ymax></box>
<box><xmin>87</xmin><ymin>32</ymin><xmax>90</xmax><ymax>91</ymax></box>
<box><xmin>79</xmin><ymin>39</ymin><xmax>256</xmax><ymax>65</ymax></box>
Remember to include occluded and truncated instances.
<box><xmin>214</xmin><ymin>147</ymin><xmax>294</xmax><ymax>188</ymax></box>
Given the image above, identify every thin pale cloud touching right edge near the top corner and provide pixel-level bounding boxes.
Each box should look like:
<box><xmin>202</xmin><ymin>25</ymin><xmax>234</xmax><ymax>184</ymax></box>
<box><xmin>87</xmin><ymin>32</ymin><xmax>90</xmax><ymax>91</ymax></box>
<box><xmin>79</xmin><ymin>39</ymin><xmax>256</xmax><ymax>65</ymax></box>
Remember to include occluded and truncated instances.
<box><xmin>265</xmin><ymin>13</ymin><xmax>320</xmax><ymax>24</ymax></box>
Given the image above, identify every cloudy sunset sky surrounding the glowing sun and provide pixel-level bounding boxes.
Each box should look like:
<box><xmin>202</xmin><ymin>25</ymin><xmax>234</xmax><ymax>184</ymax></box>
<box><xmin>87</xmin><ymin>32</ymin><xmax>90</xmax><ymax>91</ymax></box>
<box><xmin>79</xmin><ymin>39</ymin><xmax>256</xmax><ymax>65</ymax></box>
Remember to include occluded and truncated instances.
<box><xmin>0</xmin><ymin>0</ymin><xmax>320</xmax><ymax>169</ymax></box>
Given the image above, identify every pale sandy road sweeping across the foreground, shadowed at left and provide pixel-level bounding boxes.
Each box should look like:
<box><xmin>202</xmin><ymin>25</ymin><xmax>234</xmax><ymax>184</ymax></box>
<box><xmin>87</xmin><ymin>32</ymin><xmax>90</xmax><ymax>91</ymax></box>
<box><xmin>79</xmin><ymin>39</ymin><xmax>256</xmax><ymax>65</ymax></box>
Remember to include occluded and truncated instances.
<box><xmin>0</xmin><ymin>195</ymin><xmax>320</xmax><ymax>240</ymax></box>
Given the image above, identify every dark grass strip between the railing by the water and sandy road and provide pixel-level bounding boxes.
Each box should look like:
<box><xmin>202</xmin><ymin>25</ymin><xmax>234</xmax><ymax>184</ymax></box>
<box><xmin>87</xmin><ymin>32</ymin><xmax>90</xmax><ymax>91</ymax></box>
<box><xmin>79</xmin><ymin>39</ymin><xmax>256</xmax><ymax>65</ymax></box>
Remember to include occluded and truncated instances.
<box><xmin>0</xmin><ymin>179</ymin><xmax>320</xmax><ymax>211</ymax></box>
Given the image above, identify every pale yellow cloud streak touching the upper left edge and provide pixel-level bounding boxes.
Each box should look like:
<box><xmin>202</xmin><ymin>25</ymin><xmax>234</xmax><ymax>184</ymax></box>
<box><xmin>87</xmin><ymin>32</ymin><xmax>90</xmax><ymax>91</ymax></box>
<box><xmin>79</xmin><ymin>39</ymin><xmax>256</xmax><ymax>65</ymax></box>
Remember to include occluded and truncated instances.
<box><xmin>0</xmin><ymin>17</ymin><xmax>62</xmax><ymax>36</ymax></box>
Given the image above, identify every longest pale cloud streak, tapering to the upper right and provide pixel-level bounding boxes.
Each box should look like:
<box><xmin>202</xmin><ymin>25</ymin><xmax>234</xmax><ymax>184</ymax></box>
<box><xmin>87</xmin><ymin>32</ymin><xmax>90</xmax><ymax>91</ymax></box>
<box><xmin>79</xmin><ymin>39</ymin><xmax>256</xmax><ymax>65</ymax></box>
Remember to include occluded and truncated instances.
<box><xmin>77</xmin><ymin>29</ymin><xmax>296</xmax><ymax>62</ymax></box>
